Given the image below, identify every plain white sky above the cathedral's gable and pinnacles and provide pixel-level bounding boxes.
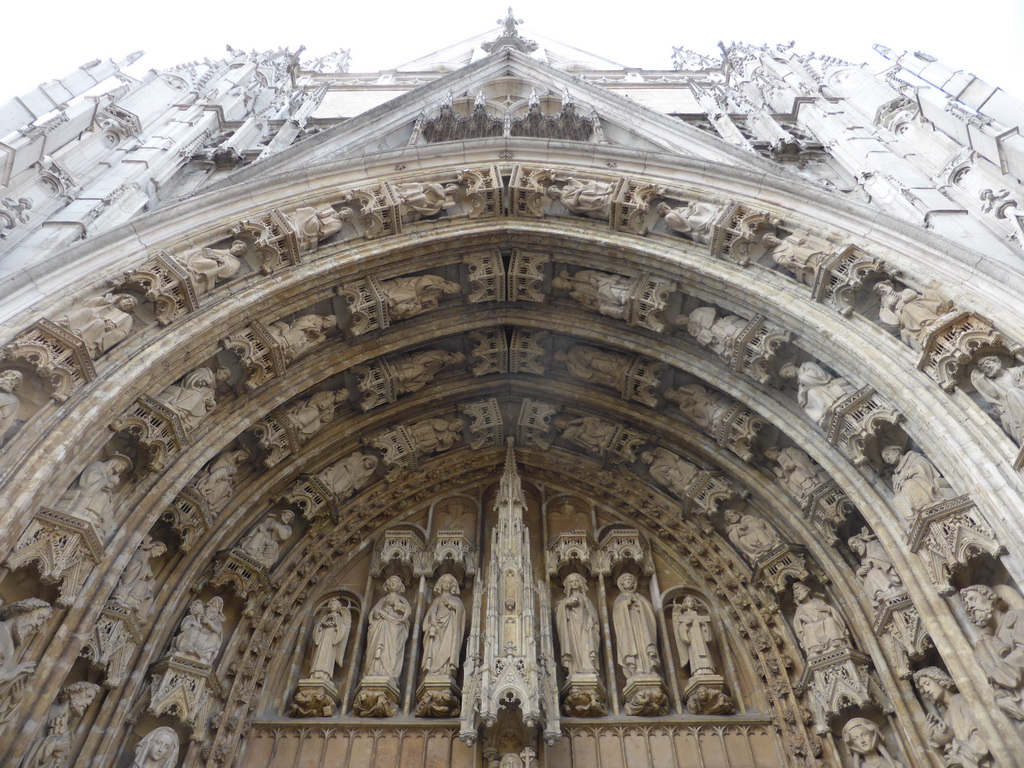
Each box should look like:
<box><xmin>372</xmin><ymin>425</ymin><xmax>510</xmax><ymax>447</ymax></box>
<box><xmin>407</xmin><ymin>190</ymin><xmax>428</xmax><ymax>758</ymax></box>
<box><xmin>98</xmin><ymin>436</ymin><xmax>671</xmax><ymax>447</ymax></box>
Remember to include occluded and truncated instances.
<box><xmin>0</xmin><ymin>0</ymin><xmax>1024</xmax><ymax>103</ymax></box>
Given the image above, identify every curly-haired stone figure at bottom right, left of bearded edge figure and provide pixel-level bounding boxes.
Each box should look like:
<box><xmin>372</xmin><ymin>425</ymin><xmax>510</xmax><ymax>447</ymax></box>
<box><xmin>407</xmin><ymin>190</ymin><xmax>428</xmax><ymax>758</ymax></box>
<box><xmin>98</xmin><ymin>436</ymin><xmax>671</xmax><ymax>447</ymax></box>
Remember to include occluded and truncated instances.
<box><xmin>913</xmin><ymin>667</ymin><xmax>992</xmax><ymax>768</ymax></box>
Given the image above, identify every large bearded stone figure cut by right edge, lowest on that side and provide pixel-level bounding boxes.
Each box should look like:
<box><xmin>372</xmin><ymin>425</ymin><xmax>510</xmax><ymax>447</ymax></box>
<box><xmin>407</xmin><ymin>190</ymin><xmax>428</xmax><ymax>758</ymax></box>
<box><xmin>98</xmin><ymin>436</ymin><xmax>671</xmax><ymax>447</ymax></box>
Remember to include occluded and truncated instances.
<box><xmin>959</xmin><ymin>584</ymin><xmax>1024</xmax><ymax>721</ymax></box>
